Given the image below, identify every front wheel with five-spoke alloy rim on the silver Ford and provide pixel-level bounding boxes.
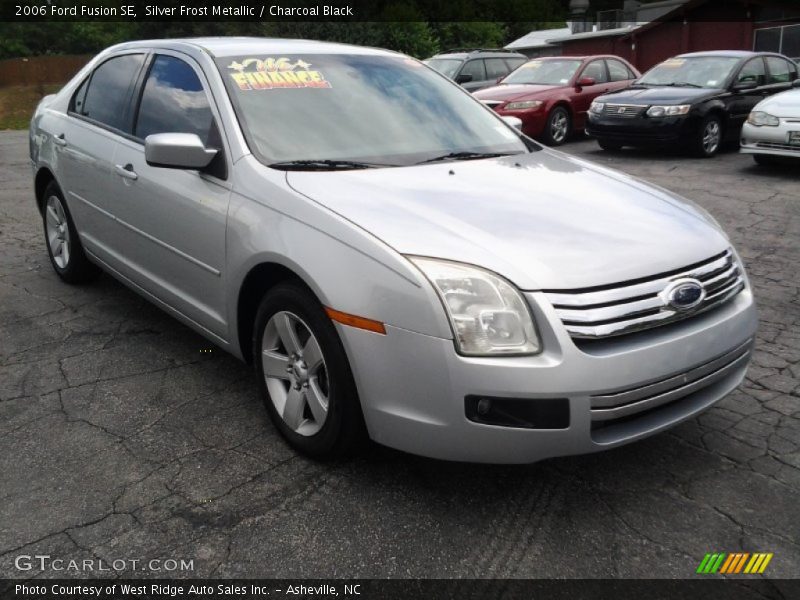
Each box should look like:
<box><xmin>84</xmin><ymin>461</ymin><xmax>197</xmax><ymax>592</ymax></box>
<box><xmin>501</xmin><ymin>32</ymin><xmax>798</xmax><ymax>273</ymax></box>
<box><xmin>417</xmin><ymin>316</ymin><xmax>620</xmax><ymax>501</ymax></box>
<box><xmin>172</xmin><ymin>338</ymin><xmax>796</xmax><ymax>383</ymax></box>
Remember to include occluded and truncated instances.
<box><xmin>252</xmin><ymin>283</ymin><xmax>366</xmax><ymax>459</ymax></box>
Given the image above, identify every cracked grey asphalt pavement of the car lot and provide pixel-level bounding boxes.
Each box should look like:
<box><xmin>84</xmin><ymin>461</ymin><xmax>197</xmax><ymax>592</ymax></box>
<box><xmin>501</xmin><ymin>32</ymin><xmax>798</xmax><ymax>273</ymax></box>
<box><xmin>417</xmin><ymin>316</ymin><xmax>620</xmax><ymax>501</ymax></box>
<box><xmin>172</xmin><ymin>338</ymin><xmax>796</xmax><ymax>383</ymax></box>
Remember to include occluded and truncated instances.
<box><xmin>0</xmin><ymin>131</ymin><xmax>800</xmax><ymax>578</ymax></box>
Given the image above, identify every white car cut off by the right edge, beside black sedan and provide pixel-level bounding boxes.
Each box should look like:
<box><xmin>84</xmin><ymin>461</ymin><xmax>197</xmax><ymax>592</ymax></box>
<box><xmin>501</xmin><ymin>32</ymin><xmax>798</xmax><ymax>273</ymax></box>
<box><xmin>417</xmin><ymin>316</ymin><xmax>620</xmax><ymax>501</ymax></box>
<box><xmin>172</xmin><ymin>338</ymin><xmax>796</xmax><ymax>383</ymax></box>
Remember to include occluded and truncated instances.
<box><xmin>741</xmin><ymin>79</ymin><xmax>800</xmax><ymax>165</ymax></box>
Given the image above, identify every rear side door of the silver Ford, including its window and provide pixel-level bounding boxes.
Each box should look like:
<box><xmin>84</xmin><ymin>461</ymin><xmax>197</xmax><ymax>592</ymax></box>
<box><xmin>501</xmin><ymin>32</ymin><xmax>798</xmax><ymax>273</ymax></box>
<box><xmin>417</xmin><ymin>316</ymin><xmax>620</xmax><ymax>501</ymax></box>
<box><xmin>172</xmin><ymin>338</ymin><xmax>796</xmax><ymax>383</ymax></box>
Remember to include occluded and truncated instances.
<box><xmin>53</xmin><ymin>52</ymin><xmax>145</xmax><ymax>260</ymax></box>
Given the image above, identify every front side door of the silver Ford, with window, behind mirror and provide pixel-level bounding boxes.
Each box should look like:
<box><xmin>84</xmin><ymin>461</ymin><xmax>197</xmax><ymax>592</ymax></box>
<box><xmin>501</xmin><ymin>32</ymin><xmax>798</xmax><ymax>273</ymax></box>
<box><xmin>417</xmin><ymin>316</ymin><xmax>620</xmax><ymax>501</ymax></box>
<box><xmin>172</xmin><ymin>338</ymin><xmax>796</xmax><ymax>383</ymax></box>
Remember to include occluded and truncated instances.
<box><xmin>108</xmin><ymin>52</ymin><xmax>230</xmax><ymax>339</ymax></box>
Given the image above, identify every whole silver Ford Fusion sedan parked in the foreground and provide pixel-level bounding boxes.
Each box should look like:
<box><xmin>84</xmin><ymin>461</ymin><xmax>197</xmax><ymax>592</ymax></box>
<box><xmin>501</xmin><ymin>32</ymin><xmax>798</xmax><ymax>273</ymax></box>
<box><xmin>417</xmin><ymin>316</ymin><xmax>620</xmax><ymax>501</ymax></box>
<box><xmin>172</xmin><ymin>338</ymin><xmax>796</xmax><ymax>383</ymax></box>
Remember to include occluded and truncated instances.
<box><xmin>30</xmin><ymin>38</ymin><xmax>756</xmax><ymax>463</ymax></box>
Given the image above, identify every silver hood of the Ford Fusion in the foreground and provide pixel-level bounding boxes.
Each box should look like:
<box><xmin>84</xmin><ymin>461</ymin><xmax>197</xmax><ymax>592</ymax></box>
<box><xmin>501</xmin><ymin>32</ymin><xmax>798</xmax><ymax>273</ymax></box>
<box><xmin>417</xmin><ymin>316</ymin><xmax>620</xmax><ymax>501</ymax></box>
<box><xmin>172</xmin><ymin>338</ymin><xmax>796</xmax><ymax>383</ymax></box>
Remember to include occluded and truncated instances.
<box><xmin>287</xmin><ymin>150</ymin><xmax>728</xmax><ymax>290</ymax></box>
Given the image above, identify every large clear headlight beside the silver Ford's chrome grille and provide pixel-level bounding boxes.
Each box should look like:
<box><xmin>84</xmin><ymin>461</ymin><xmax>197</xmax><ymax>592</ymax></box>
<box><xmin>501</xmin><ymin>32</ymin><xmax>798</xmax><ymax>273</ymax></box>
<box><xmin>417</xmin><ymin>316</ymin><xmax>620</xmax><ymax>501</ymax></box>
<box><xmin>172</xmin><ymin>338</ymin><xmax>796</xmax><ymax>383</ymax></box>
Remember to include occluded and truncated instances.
<box><xmin>409</xmin><ymin>257</ymin><xmax>541</xmax><ymax>356</ymax></box>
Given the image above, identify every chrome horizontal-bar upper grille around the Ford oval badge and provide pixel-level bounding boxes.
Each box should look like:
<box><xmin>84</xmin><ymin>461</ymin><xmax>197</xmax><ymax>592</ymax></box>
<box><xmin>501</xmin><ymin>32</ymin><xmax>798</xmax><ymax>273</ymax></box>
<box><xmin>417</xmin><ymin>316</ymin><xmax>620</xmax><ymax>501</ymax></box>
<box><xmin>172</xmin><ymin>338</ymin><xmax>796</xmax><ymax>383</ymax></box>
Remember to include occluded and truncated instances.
<box><xmin>544</xmin><ymin>250</ymin><xmax>744</xmax><ymax>339</ymax></box>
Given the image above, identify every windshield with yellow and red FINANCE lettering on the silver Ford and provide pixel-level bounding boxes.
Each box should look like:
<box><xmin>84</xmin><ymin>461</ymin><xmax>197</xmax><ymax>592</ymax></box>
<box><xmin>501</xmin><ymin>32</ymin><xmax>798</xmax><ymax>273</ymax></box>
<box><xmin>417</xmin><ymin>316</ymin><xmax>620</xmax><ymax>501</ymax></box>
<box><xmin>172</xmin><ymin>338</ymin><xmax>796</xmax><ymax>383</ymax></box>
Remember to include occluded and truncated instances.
<box><xmin>217</xmin><ymin>54</ymin><xmax>528</xmax><ymax>168</ymax></box>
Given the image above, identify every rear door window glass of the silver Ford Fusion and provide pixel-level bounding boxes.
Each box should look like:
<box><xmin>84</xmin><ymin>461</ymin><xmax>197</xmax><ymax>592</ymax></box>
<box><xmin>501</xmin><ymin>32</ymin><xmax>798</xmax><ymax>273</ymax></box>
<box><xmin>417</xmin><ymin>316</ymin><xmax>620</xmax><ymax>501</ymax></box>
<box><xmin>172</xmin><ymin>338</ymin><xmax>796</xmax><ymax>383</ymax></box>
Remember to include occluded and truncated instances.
<box><xmin>80</xmin><ymin>54</ymin><xmax>144</xmax><ymax>132</ymax></box>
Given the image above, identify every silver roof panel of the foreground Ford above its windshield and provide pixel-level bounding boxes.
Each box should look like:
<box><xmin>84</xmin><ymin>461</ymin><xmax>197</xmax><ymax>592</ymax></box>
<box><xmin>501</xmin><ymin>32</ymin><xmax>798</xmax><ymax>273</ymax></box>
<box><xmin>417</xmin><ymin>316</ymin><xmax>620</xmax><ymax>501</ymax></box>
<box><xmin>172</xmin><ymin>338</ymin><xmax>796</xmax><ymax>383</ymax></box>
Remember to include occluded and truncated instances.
<box><xmin>107</xmin><ymin>37</ymin><xmax>397</xmax><ymax>57</ymax></box>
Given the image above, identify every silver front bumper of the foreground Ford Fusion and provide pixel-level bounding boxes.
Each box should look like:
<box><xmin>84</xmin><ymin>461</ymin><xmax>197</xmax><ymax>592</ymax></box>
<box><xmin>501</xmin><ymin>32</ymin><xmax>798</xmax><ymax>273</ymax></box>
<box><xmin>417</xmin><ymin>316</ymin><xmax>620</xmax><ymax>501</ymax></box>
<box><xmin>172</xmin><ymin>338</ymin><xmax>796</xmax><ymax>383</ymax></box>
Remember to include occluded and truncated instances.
<box><xmin>337</xmin><ymin>287</ymin><xmax>756</xmax><ymax>464</ymax></box>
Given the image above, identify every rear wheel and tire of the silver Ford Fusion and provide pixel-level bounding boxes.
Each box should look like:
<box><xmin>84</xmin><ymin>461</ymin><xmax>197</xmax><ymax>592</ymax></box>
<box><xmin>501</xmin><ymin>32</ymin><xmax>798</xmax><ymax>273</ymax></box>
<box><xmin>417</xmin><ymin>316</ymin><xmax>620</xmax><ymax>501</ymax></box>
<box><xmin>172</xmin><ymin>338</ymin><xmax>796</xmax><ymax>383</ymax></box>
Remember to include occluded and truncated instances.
<box><xmin>42</xmin><ymin>181</ymin><xmax>100</xmax><ymax>284</ymax></box>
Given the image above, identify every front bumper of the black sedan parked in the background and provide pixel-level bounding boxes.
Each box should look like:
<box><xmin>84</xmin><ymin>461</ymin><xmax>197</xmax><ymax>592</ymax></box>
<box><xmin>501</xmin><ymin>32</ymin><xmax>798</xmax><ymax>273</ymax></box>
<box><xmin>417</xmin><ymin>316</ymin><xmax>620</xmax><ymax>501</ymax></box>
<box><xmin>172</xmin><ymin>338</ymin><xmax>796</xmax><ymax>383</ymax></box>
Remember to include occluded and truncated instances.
<box><xmin>586</xmin><ymin>113</ymin><xmax>699</xmax><ymax>146</ymax></box>
